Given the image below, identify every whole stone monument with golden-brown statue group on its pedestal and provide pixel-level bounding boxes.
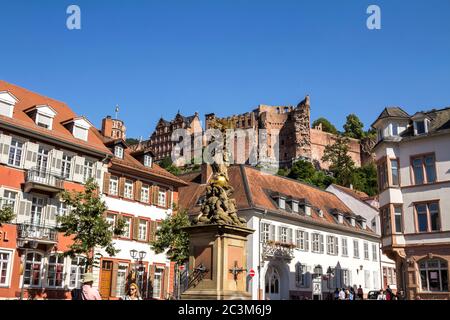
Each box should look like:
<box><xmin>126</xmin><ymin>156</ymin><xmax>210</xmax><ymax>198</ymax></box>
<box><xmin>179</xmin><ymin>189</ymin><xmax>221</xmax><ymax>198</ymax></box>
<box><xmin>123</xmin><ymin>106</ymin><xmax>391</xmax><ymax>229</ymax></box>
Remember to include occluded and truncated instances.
<box><xmin>181</xmin><ymin>120</ymin><xmax>254</xmax><ymax>300</ymax></box>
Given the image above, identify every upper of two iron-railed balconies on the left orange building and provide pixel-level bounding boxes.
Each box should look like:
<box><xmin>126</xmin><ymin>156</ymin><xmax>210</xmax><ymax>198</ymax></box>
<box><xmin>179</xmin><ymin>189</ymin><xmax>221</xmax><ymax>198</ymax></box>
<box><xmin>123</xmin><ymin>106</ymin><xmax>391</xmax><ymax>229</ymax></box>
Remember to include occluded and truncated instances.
<box><xmin>24</xmin><ymin>168</ymin><xmax>64</xmax><ymax>195</ymax></box>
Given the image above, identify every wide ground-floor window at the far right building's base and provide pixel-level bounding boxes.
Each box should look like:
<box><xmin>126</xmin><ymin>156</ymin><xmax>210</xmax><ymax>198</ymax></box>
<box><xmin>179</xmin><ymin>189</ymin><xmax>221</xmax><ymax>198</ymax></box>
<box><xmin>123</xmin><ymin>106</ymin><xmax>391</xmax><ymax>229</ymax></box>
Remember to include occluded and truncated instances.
<box><xmin>419</xmin><ymin>259</ymin><xmax>448</xmax><ymax>292</ymax></box>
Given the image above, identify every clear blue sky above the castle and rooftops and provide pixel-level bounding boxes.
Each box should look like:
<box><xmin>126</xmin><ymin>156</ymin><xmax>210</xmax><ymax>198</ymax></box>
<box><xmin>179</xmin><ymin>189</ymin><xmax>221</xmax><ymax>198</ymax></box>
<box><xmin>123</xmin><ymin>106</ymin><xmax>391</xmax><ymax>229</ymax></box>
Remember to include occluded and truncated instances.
<box><xmin>0</xmin><ymin>0</ymin><xmax>450</xmax><ymax>138</ymax></box>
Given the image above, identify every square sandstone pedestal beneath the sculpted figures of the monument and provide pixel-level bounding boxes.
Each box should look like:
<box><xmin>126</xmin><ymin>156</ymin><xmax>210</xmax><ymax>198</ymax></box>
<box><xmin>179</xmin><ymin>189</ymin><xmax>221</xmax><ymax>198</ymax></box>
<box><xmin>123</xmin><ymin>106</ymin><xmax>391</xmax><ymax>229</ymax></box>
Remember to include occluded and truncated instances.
<box><xmin>181</xmin><ymin>224</ymin><xmax>254</xmax><ymax>300</ymax></box>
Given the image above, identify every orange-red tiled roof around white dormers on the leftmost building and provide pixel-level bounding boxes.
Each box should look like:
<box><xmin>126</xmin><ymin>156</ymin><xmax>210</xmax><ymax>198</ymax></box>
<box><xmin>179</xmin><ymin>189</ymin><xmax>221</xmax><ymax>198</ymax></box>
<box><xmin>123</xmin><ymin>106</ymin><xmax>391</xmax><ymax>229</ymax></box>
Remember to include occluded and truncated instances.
<box><xmin>0</xmin><ymin>80</ymin><xmax>111</xmax><ymax>154</ymax></box>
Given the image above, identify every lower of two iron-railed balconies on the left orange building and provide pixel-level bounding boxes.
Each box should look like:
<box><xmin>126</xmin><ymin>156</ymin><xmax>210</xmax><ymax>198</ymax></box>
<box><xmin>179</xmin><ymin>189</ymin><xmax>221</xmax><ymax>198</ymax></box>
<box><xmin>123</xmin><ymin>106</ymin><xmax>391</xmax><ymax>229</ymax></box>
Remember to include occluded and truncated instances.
<box><xmin>17</xmin><ymin>222</ymin><xmax>58</xmax><ymax>247</ymax></box>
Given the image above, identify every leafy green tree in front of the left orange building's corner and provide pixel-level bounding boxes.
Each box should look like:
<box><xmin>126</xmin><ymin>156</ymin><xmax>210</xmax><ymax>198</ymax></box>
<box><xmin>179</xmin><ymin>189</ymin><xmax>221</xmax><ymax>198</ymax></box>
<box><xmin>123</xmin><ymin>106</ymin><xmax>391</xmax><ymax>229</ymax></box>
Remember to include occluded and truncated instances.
<box><xmin>57</xmin><ymin>178</ymin><xmax>125</xmax><ymax>269</ymax></box>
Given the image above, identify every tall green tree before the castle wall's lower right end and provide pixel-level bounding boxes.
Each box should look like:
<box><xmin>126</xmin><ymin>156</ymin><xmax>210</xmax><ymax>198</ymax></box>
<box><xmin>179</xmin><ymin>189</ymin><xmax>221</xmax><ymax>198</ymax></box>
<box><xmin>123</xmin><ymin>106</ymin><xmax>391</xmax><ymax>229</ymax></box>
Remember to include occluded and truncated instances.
<box><xmin>322</xmin><ymin>135</ymin><xmax>355</xmax><ymax>187</ymax></box>
